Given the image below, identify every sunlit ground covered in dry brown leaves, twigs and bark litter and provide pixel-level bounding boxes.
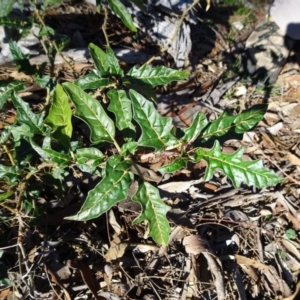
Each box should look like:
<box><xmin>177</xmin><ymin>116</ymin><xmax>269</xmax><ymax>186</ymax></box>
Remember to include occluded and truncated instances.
<box><xmin>0</xmin><ymin>1</ymin><xmax>300</xmax><ymax>300</ymax></box>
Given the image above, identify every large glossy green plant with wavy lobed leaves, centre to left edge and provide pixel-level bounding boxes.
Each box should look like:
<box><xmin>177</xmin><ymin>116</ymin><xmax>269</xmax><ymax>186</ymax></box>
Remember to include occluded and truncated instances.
<box><xmin>0</xmin><ymin>43</ymin><xmax>281</xmax><ymax>245</ymax></box>
